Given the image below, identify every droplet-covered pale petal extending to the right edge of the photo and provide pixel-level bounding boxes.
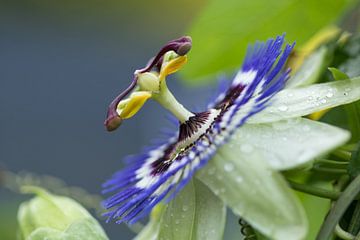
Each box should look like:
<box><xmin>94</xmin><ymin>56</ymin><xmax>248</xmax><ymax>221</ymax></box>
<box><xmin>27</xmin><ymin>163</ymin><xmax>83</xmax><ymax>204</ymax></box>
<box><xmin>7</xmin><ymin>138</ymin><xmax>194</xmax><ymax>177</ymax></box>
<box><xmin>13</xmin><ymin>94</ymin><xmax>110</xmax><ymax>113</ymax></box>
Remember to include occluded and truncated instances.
<box><xmin>248</xmin><ymin>77</ymin><xmax>360</xmax><ymax>123</ymax></box>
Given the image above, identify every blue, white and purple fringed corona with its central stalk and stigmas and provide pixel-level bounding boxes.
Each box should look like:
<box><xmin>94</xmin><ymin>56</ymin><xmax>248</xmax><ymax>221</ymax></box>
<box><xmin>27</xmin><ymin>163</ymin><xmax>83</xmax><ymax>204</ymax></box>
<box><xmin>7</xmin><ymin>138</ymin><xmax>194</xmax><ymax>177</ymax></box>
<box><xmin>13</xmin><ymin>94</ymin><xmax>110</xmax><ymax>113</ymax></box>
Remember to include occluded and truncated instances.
<box><xmin>103</xmin><ymin>36</ymin><xmax>293</xmax><ymax>223</ymax></box>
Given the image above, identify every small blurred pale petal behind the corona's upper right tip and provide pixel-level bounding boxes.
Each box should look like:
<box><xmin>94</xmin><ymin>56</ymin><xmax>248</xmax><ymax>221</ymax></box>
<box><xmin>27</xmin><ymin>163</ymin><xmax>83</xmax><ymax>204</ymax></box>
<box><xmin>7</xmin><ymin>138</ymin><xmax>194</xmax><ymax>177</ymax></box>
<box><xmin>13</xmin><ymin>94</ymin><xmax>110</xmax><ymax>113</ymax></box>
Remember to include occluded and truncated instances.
<box><xmin>286</xmin><ymin>46</ymin><xmax>328</xmax><ymax>88</ymax></box>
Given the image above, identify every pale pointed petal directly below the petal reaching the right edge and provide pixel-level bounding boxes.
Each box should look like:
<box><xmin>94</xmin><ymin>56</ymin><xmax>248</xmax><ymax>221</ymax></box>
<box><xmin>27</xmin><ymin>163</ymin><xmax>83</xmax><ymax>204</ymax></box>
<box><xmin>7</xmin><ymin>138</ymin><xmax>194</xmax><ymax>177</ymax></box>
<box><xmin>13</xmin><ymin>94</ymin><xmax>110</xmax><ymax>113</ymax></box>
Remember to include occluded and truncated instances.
<box><xmin>229</xmin><ymin>118</ymin><xmax>350</xmax><ymax>170</ymax></box>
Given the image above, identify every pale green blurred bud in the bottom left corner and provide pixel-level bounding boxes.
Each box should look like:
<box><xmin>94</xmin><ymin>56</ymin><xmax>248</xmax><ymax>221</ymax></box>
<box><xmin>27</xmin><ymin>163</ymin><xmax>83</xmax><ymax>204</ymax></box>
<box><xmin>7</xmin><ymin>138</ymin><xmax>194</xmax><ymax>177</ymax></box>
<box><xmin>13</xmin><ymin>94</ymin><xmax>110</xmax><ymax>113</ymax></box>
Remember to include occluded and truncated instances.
<box><xmin>18</xmin><ymin>186</ymin><xmax>108</xmax><ymax>240</ymax></box>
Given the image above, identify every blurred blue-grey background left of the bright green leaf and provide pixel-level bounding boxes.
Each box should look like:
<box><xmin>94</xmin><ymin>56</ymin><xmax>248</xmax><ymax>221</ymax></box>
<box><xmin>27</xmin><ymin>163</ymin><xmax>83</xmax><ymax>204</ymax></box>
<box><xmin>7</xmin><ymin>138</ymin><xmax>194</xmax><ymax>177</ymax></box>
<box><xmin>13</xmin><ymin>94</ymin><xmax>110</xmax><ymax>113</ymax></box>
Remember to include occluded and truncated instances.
<box><xmin>0</xmin><ymin>0</ymin><xmax>217</xmax><ymax>240</ymax></box>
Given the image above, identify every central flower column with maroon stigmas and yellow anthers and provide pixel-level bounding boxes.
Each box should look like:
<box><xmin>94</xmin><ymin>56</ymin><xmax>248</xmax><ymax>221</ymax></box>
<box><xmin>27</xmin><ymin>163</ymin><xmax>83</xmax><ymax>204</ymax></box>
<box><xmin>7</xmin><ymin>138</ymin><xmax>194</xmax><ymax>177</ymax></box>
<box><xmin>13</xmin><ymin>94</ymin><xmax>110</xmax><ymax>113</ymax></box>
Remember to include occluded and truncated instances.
<box><xmin>104</xmin><ymin>36</ymin><xmax>195</xmax><ymax>131</ymax></box>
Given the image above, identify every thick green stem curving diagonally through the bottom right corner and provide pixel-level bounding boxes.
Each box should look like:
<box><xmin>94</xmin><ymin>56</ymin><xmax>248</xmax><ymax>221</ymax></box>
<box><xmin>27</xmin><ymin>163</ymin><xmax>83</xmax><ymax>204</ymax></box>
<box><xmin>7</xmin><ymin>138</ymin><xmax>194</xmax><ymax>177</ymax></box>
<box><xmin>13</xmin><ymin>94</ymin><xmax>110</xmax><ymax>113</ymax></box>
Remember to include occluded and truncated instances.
<box><xmin>316</xmin><ymin>175</ymin><xmax>360</xmax><ymax>240</ymax></box>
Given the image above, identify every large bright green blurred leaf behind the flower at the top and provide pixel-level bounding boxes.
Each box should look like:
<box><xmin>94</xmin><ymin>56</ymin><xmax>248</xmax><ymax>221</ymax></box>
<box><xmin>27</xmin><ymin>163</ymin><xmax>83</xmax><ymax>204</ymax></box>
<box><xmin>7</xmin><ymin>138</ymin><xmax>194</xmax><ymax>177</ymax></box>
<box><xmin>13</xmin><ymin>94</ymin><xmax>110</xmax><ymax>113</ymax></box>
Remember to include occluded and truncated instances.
<box><xmin>182</xmin><ymin>0</ymin><xmax>355</xmax><ymax>84</ymax></box>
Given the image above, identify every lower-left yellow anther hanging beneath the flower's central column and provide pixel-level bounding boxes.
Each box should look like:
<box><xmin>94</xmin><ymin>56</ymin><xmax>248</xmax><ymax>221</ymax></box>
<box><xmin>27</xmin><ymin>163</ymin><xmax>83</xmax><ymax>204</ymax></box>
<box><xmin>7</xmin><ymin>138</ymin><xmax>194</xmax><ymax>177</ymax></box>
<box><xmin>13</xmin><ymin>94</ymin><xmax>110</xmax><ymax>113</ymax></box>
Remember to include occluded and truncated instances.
<box><xmin>118</xmin><ymin>91</ymin><xmax>151</xmax><ymax>119</ymax></box>
